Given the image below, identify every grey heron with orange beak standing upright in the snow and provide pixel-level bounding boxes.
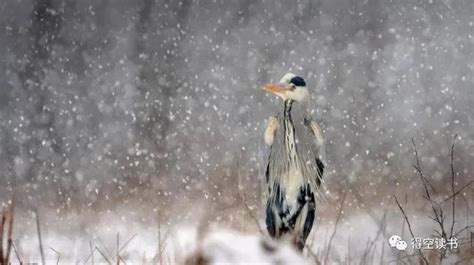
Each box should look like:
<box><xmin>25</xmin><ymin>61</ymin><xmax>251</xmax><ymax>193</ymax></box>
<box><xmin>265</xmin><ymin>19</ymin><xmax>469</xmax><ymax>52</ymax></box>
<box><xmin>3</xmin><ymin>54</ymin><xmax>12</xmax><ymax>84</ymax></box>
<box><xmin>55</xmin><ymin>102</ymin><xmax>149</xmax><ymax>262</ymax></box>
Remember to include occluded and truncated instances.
<box><xmin>263</xmin><ymin>73</ymin><xmax>324</xmax><ymax>250</ymax></box>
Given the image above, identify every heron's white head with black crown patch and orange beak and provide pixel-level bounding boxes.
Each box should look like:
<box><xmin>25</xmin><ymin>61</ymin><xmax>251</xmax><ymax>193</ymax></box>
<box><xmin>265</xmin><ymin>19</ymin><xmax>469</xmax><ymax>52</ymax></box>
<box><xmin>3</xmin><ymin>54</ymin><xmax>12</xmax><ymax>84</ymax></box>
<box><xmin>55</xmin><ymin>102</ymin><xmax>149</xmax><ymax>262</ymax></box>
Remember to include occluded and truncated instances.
<box><xmin>263</xmin><ymin>73</ymin><xmax>309</xmax><ymax>103</ymax></box>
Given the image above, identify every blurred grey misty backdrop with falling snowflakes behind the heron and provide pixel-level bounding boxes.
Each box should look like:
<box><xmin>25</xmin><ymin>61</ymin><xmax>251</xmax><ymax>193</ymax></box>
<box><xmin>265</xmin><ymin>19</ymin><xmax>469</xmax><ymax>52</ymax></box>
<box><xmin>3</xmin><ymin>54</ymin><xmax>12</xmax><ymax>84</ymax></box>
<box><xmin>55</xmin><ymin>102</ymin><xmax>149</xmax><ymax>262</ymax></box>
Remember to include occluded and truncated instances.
<box><xmin>0</xmin><ymin>0</ymin><xmax>474</xmax><ymax>238</ymax></box>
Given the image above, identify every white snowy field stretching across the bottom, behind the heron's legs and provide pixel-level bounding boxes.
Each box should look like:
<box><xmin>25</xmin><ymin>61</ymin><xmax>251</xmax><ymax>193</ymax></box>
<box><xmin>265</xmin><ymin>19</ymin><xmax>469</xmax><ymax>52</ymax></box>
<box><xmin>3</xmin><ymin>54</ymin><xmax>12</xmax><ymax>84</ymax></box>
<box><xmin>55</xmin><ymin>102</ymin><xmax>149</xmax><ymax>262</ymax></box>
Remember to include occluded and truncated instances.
<box><xmin>6</xmin><ymin>183</ymin><xmax>472</xmax><ymax>264</ymax></box>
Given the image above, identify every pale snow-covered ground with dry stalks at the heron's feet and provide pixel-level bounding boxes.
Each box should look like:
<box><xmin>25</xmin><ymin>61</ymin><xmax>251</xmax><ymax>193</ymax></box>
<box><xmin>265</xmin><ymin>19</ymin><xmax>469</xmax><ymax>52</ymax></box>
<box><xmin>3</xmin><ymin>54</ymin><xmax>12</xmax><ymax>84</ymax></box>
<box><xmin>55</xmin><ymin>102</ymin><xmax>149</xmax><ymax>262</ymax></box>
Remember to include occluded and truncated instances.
<box><xmin>9</xmin><ymin>195</ymin><xmax>472</xmax><ymax>264</ymax></box>
